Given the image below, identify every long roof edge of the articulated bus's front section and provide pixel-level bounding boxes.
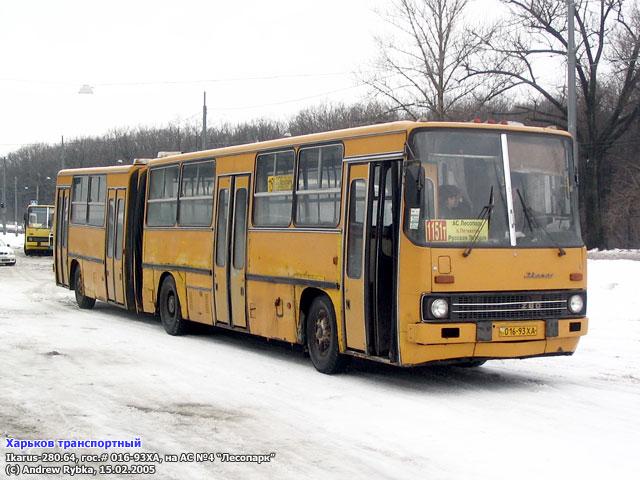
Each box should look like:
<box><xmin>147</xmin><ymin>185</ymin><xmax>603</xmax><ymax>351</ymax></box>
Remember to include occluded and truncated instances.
<box><xmin>149</xmin><ymin>121</ymin><xmax>570</xmax><ymax>166</ymax></box>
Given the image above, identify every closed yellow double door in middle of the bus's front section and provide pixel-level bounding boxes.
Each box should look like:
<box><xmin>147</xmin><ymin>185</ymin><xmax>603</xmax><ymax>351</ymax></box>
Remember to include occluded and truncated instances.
<box><xmin>213</xmin><ymin>175</ymin><xmax>249</xmax><ymax>328</ymax></box>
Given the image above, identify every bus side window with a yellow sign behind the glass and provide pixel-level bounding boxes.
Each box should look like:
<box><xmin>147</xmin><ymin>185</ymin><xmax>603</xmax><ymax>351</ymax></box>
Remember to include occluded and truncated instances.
<box><xmin>253</xmin><ymin>150</ymin><xmax>294</xmax><ymax>227</ymax></box>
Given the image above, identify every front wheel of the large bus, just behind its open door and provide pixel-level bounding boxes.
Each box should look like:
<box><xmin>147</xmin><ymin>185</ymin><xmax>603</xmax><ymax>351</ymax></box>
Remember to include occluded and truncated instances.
<box><xmin>306</xmin><ymin>296</ymin><xmax>347</xmax><ymax>374</ymax></box>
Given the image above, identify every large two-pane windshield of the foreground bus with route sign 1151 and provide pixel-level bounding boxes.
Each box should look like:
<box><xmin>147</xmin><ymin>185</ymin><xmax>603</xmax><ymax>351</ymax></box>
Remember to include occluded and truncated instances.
<box><xmin>405</xmin><ymin>130</ymin><xmax>582</xmax><ymax>247</ymax></box>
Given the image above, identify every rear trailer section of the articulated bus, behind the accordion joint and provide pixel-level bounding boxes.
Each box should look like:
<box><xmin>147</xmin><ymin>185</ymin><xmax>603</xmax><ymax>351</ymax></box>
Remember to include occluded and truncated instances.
<box><xmin>54</xmin><ymin>162</ymin><xmax>144</xmax><ymax>311</ymax></box>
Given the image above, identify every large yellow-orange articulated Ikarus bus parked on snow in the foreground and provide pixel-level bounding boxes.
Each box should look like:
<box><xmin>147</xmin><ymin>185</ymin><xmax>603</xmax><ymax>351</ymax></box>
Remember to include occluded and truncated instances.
<box><xmin>55</xmin><ymin>122</ymin><xmax>588</xmax><ymax>373</ymax></box>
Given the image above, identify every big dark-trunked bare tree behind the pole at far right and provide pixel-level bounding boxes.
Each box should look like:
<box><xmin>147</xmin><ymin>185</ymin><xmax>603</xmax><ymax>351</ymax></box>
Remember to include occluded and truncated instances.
<box><xmin>468</xmin><ymin>0</ymin><xmax>640</xmax><ymax>247</ymax></box>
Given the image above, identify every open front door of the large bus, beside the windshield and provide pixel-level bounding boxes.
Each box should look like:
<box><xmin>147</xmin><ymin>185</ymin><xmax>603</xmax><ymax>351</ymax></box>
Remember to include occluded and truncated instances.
<box><xmin>343</xmin><ymin>161</ymin><xmax>400</xmax><ymax>360</ymax></box>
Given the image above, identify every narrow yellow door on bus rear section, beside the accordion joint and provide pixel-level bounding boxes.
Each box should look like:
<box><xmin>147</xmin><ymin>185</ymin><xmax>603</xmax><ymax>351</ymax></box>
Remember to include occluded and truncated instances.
<box><xmin>105</xmin><ymin>188</ymin><xmax>126</xmax><ymax>305</ymax></box>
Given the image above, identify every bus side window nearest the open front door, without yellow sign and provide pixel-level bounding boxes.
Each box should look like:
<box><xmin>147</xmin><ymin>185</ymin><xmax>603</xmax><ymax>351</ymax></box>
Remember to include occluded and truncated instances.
<box><xmin>296</xmin><ymin>145</ymin><xmax>342</xmax><ymax>227</ymax></box>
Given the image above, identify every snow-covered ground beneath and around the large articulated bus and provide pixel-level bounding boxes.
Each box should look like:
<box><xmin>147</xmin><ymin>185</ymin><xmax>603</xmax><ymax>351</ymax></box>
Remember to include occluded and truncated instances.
<box><xmin>0</xmin><ymin>251</ymin><xmax>640</xmax><ymax>479</ymax></box>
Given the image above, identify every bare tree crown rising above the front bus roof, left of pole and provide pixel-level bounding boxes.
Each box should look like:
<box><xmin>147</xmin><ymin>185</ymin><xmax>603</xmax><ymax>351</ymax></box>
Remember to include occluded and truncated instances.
<box><xmin>367</xmin><ymin>0</ymin><xmax>490</xmax><ymax>120</ymax></box>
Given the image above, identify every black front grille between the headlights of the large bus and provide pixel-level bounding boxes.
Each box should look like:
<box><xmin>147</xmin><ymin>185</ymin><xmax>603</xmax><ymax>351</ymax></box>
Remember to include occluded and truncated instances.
<box><xmin>451</xmin><ymin>292</ymin><xmax>569</xmax><ymax>320</ymax></box>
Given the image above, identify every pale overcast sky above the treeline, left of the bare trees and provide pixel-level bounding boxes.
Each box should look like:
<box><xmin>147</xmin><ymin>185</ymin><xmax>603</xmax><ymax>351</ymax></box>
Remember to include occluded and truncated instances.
<box><xmin>0</xmin><ymin>0</ymin><xmax>508</xmax><ymax>154</ymax></box>
